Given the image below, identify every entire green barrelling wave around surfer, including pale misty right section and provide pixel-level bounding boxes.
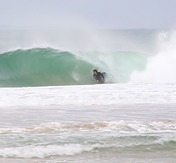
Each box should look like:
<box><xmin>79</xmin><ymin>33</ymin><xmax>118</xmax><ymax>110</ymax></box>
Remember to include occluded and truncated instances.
<box><xmin>0</xmin><ymin>48</ymin><xmax>147</xmax><ymax>87</ymax></box>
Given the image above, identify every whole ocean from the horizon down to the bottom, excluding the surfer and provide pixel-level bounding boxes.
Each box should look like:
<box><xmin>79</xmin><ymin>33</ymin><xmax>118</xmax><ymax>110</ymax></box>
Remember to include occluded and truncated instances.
<box><xmin>0</xmin><ymin>29</ymin><xmax>176</xmax><ymax>163</ymax></box>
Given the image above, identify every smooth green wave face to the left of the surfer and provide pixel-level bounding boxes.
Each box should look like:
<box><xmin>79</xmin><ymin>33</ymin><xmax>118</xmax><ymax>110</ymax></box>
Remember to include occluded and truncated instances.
<box><xmin>0</xmin><ymin>48</ymin><xmax>93</xmax><ymax>86</ymax></box>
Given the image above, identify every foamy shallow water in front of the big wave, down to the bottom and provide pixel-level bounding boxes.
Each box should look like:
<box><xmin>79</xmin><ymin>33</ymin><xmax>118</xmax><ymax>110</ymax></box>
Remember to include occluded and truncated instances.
<box><xmin>0</xmin><ymin>84</ymin><xmax>176</xmax><ymax>162</ymax></box>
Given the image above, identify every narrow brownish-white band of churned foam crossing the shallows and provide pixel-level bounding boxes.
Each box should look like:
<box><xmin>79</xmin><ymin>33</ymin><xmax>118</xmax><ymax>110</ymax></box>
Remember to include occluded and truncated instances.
<box><xmin>0</xmin><ymin>120</ymin><xmax>176</xmax><ymax>134</ymax></box>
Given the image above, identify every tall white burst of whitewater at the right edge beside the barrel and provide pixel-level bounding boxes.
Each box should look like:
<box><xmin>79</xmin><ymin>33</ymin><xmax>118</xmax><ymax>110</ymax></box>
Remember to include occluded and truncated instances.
<box><xmin>131</xmin><ymin>31</ymin><xmax>176</xmax><ymax>83</ymax></box>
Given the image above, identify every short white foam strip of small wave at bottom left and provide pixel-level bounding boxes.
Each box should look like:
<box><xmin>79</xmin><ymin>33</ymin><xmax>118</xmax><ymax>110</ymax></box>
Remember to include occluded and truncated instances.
<box><xmin>0</xmin><ymin>144</ymin><xmax>92</xmax><ymax>158</ymax></box>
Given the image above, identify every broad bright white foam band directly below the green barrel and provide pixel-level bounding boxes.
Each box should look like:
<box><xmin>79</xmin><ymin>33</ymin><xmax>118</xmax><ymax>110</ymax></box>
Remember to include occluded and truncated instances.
<box><xmin>0</xmin><ymin>84</ymin><xmax>176</xmax><ymax>108</ymax></box>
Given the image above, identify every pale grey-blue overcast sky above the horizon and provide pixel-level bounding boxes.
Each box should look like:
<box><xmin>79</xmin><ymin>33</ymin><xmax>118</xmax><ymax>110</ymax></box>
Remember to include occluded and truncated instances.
<box><xmin>0</xmin><ymin>0</ymin><xmax>176</xmax><ymax>29</ymax></box>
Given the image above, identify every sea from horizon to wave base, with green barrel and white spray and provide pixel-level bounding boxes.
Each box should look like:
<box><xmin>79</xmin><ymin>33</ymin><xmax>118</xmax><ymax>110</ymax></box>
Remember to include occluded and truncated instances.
<box><xmin>0</xmin><ymin>30</ymin><xmax>176</xmax><ymax>86</ymax></box>
